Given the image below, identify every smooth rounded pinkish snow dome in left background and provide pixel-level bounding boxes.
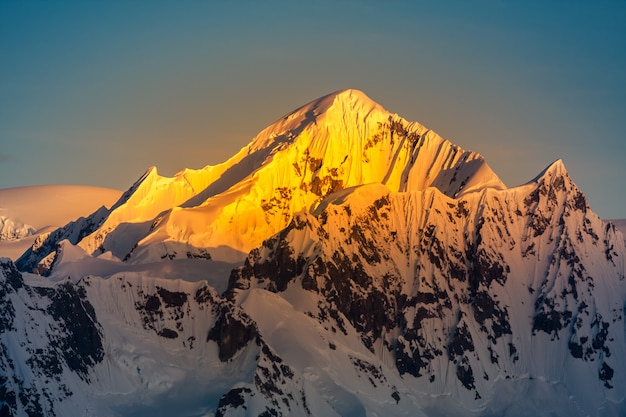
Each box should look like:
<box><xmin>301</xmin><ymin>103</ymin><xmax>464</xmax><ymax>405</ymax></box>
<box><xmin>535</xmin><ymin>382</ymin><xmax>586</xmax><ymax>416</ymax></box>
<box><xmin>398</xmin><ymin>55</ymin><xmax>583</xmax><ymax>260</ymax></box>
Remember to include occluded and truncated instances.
<box><xmin>0</xmin><ymin>185</ymin><xmax>122</xmax><ymax>259</ymax></box>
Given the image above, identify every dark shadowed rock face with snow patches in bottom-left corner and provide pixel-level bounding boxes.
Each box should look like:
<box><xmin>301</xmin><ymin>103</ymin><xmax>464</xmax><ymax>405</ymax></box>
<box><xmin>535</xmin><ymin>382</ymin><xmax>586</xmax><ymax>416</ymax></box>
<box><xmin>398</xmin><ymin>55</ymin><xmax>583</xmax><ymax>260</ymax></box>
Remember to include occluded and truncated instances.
<box><xmin>0</xmin><ymin>262</ymin><xmax>104</xmax><ymax>416</ymax></box>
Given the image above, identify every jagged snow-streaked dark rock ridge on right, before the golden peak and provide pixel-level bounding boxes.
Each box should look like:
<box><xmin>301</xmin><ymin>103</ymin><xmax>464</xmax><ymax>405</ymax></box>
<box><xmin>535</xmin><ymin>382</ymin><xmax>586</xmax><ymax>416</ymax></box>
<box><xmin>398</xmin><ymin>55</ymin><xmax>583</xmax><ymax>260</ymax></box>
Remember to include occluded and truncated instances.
<box><xmin>229</xmin><ymin>161</ymin><xmax>626</xmax><ymax>416</ymax></box>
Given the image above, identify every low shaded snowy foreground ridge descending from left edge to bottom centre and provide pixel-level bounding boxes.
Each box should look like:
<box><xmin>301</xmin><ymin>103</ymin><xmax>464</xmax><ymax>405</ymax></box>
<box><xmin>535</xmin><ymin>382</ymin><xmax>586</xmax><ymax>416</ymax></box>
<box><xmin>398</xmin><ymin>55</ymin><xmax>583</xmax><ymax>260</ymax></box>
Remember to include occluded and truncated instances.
<box><xmin>0</xmin><ymin>259</ymin><xmax>412</xmax><ymax>416</ymax></box>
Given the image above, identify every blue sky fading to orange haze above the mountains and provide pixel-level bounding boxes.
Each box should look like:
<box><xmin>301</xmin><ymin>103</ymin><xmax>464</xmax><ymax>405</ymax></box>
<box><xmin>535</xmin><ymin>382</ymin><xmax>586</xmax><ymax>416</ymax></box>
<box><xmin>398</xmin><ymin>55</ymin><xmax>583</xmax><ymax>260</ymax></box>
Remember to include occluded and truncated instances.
<box><xmin>0</xmin><ymin>0</ymin><xmax>626</xmax><ymax>219</ymax></box>
